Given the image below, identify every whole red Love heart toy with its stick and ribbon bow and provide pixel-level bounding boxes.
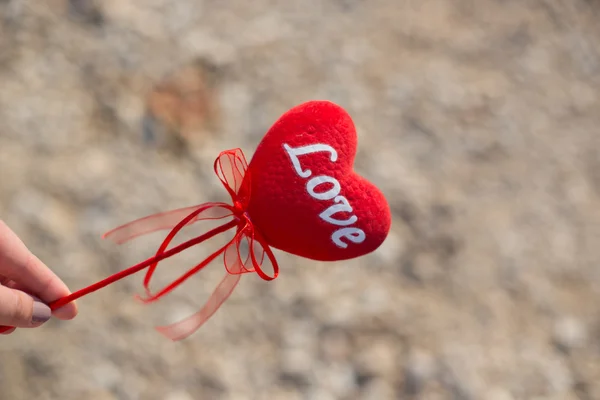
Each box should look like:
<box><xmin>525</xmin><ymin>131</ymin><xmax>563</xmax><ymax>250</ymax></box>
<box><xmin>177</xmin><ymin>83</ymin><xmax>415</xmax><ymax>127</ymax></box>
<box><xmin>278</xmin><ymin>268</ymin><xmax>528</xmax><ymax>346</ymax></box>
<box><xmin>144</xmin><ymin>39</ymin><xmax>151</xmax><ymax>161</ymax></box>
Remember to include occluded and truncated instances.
<box><xmin>0</xmin><ymin>101</ymin><xmax>391</xmax><ymax>340</ymax></box>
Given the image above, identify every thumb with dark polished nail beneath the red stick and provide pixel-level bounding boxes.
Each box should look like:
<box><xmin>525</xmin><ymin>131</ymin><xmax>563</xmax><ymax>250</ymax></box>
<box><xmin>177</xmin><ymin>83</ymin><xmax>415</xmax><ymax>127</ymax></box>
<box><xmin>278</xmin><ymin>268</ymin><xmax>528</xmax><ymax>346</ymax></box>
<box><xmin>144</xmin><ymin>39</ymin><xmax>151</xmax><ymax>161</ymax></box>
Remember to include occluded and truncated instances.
<box><xmin>0</xmin><ymin>286</ymin><xmax>52</xmax><ymax>328</ymax></box>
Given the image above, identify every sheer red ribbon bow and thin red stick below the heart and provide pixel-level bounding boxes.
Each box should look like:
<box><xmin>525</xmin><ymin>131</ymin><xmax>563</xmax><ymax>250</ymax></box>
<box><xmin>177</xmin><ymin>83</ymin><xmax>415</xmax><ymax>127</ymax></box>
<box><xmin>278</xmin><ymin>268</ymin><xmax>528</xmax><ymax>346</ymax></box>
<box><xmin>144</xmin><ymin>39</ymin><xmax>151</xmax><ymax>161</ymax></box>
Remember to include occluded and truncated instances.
<box><xmin>0</xmin><ymin>149</ymin><xmax>279</xmax><ymax>340</ymax></box>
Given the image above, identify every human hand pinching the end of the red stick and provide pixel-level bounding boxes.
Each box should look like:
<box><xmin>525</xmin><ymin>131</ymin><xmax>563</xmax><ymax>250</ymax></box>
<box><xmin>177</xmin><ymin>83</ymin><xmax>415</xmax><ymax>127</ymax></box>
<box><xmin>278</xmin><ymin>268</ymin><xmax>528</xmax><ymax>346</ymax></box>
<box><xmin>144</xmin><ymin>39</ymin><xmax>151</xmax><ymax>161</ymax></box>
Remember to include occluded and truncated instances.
<box><xmin>0</xmin><ymin>220</ymin><xmax>77</xmax><ymax>334</ymax></box>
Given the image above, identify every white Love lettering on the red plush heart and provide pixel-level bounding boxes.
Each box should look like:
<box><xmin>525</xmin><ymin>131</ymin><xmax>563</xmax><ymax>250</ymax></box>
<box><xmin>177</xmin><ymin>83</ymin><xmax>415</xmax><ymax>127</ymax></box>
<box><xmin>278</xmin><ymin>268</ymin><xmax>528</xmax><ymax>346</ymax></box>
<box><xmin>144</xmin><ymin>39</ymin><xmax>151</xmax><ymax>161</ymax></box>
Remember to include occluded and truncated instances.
<box><xmin>283</xmin><ymin>143</ymin><xmax>366</xmax><ymax>249</ymax></box>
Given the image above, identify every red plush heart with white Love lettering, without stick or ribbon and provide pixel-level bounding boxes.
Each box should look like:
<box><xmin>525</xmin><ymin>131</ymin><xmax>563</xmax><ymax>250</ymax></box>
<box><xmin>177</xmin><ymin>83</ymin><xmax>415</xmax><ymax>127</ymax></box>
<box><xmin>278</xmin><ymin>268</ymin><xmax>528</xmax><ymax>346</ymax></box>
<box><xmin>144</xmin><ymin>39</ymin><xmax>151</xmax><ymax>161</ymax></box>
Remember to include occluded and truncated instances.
<box><xmin>248</xmin><ymin>101</ymin><xmax>391</xmax><ymax>261</ymax></box>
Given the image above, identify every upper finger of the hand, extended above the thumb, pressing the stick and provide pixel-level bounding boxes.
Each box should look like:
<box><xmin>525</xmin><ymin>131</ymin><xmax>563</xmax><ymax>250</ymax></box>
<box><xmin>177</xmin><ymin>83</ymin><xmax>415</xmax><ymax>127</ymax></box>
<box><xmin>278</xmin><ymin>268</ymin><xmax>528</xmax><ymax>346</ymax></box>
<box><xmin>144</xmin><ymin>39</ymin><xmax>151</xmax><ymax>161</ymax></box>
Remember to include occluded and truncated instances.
<box><xmin>0</xmin><ymin>221</ymin><xmax>77</xmax><ymax>320</ymax></box>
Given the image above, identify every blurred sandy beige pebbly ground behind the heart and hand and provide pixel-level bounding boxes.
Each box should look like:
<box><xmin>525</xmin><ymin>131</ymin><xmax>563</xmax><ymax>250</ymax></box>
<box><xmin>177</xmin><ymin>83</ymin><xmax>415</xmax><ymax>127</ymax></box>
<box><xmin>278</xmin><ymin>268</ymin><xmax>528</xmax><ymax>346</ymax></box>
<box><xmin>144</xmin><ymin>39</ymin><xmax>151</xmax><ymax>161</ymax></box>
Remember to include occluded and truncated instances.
<box><xmin>0</xmin><ymin>0</ymin><xmax>600</xmax><ymax>400</ymax></box>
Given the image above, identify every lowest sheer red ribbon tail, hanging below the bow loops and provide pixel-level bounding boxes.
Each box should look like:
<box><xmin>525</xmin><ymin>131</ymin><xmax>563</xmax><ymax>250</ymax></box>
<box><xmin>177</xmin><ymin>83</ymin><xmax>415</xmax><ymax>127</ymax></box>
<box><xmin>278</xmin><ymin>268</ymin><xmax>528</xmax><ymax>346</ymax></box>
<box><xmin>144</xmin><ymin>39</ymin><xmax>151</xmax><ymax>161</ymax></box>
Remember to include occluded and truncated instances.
<box><xmin>155</xmin><ymin>273</ymin><xmax>241</xmax><ymax>341</ymax></box>
